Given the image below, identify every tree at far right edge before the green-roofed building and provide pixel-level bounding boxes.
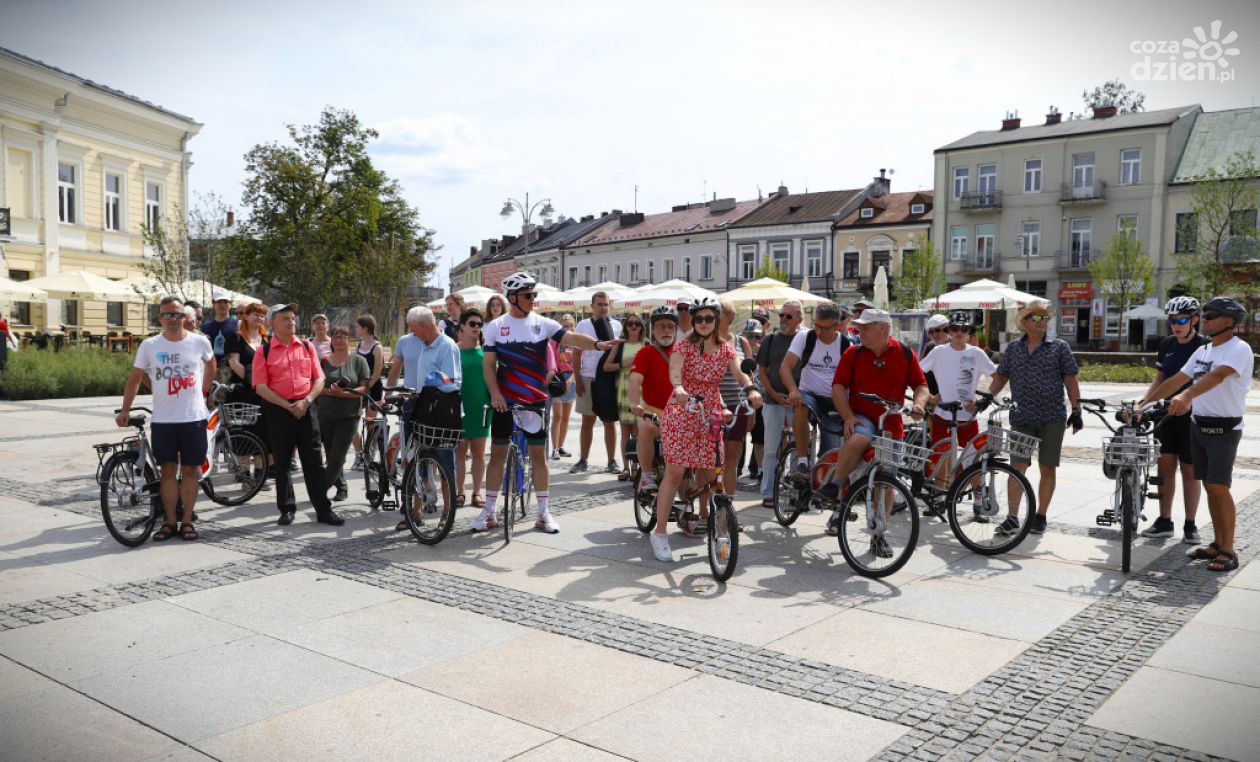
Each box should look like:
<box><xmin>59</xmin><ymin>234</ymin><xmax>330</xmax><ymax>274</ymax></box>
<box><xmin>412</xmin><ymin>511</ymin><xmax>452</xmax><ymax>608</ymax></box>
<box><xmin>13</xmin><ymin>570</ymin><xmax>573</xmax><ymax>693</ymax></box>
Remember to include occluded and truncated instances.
<box><xmin>1177</xmin><ymin>151</ymin><xmax>1260</xmax><ymax>299</ymax></box>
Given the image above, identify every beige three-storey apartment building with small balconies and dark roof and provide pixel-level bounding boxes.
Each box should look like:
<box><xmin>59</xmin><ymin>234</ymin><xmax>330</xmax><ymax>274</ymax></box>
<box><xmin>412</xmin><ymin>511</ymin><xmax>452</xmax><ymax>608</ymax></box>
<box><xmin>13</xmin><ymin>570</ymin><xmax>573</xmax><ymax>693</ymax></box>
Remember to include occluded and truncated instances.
<box><xmin>932</xmin><ymin>106</ymin><xmax>1202</xmax><ymax>345</ymax></box>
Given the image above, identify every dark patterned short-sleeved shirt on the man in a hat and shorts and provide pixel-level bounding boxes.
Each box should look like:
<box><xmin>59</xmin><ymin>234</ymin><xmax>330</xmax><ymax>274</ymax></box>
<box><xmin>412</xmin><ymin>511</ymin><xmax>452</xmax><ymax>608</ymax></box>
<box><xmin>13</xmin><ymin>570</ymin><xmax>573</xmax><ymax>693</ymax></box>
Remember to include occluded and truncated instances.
<box><xmin>997</xmin><ymin>335</ymin><xmax>1080</xmax><ymax>426</ymax></box>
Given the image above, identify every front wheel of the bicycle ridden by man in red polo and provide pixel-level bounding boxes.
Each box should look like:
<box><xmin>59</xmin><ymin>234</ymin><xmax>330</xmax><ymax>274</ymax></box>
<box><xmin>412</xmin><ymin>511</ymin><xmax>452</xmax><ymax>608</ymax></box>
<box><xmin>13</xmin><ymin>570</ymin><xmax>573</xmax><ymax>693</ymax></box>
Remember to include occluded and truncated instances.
<box><xmin>839</xmin><ymin>474</ymin><xmax>919</xmax><ymax>577</ymax></box>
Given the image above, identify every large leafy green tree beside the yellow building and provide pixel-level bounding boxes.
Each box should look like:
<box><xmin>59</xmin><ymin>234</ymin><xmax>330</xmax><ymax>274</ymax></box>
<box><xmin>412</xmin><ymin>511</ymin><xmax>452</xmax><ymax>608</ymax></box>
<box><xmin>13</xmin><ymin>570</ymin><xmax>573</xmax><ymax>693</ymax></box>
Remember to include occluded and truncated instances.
<box><xmin>233</xmin><ymin>107</ymin><xmax>433</xmax><ymax>312</ymax></box>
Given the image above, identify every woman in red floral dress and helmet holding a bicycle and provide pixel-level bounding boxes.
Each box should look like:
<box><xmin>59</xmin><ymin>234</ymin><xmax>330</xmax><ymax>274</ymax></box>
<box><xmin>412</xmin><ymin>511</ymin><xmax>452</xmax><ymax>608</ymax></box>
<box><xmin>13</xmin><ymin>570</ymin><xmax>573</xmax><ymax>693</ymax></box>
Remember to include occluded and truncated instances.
<box><xmin>649</xmin><ymin>297</ymin><xmax>761</xmax><ymax>560</ymax></box>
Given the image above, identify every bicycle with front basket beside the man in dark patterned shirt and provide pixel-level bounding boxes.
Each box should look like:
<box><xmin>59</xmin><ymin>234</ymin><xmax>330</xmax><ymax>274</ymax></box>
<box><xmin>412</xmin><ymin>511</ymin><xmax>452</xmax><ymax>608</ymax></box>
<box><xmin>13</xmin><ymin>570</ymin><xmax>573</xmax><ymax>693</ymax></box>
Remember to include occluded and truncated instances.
<box><xmin>914</xmin><ymin>392</ymin><xmax>1038</xmax><ymax>555</ymax></box>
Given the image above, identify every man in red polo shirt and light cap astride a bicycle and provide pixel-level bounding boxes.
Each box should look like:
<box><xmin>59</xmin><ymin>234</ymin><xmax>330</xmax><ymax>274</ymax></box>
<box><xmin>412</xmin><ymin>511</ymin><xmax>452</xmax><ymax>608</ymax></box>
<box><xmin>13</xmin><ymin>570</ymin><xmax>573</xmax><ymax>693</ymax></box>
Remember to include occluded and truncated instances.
<box><xmin>822</xmin><ymin>309</ymin><xmax>929</xmax><ymax>534</ymax></box>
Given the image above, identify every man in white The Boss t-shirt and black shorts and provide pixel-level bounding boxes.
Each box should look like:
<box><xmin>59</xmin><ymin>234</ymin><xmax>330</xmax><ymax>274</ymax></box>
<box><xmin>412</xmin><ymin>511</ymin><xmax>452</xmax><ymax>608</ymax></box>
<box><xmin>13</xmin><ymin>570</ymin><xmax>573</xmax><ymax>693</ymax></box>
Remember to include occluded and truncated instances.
<box><xmin>115</xmin><ymin>296</ymin><xmax>214</xmax><ymax>542</ymax></box>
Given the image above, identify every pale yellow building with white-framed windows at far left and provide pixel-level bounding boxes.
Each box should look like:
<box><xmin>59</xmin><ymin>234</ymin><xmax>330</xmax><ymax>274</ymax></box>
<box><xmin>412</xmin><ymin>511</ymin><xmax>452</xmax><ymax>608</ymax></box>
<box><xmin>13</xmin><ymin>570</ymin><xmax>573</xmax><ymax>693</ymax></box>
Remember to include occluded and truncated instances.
<box><xmin>0</xmin><ymin>48</ymin><xmax>202</xmax><ymax>335</ymax></box>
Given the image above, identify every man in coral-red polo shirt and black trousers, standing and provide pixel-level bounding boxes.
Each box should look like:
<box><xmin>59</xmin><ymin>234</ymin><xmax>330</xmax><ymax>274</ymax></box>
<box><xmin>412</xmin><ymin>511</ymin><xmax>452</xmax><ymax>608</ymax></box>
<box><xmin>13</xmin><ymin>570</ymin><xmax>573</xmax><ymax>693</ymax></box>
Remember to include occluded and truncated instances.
<box><xmin>253</xmin><ymin>305</ymin><xmax>345</xmax><ymax>526</ymax></box>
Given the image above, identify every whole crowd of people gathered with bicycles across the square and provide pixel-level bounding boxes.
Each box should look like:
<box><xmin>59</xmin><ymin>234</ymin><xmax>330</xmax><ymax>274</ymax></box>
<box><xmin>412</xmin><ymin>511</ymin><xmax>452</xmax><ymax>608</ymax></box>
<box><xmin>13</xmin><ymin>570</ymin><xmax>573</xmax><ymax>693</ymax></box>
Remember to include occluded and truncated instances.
<box><xmin>117</xmin><ymin>272</ymin><xmax>1252</xmax><ymax>571</ymax></box>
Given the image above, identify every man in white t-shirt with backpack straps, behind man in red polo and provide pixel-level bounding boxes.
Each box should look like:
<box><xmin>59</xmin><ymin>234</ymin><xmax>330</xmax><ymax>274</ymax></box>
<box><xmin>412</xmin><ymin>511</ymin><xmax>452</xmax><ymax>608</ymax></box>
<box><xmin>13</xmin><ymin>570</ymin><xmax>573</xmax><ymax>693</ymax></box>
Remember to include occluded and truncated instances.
<box><xmin>779</xmin><ymin>302</ymin><xmax>849</xmax><ymax>481</ymax></box>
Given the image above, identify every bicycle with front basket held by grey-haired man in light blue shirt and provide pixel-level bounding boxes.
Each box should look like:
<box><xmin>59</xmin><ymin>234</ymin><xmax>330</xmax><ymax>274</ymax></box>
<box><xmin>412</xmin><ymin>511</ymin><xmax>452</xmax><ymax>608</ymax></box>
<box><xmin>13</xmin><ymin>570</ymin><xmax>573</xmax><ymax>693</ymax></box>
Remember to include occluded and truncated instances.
<box><xmin>359</xmin><ymin>387</ymin><xmax>464</xmax><ymax>545</ymax></box>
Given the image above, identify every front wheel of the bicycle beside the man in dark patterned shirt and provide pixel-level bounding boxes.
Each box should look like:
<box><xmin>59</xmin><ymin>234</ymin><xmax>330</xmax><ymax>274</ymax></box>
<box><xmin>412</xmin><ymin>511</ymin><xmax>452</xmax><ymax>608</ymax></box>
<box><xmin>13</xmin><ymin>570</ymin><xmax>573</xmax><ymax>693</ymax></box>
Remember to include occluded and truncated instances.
<box><xmin>945</xmin><ymin>458</ymin><xmax>1037</xmax><ymax>555</ymax></box>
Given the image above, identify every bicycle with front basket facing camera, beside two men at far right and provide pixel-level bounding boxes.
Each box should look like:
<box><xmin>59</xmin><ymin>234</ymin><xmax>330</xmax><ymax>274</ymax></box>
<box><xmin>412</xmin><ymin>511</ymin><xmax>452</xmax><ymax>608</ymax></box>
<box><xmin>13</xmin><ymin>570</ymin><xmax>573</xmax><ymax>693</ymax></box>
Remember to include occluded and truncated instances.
<box><xmin>1081</xmin><ymin>399</ymin><xmax>1167</xmax><ymax>574</ymax></box>
